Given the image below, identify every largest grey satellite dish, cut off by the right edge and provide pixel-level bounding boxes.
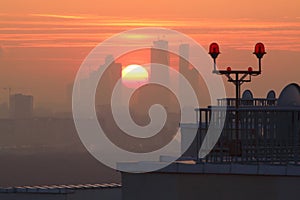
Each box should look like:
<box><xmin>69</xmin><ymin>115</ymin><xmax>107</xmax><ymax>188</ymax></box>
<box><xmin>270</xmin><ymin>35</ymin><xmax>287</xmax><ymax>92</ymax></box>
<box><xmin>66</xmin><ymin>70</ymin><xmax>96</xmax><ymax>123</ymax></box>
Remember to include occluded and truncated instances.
<box><xmin>277</xmin><ymin>83</ymin><xmax>300</xmax><ymax>106</ymax></box>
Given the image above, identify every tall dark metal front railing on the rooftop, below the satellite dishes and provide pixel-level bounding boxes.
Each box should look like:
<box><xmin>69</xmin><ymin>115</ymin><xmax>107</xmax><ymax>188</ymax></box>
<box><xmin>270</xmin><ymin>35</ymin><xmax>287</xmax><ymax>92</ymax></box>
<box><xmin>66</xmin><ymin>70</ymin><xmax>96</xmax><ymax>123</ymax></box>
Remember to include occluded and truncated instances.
<box><xmin>195</xmin><ymin>106</ymin><xmax>300</xmax><ymax>164</ymax></box>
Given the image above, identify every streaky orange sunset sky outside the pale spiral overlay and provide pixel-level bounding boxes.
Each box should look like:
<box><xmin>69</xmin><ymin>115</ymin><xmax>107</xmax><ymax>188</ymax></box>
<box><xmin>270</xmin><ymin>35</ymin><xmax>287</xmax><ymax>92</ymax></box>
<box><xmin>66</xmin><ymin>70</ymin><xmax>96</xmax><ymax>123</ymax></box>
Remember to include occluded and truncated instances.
<box><xmin>0</xmin><ymin>0</ymin><xmax>300</xmax><ymax>110</ymax></box>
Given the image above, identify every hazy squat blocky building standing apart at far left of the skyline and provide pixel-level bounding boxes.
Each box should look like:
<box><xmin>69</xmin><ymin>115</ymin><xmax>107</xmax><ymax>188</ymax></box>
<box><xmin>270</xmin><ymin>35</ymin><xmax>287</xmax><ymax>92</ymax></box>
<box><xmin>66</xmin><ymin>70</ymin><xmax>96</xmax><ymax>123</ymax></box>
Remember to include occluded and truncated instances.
<box><xmin>9</xmin><ymin>94</ymin><xmax>33</xmax><ymax>119</ymax></box>
